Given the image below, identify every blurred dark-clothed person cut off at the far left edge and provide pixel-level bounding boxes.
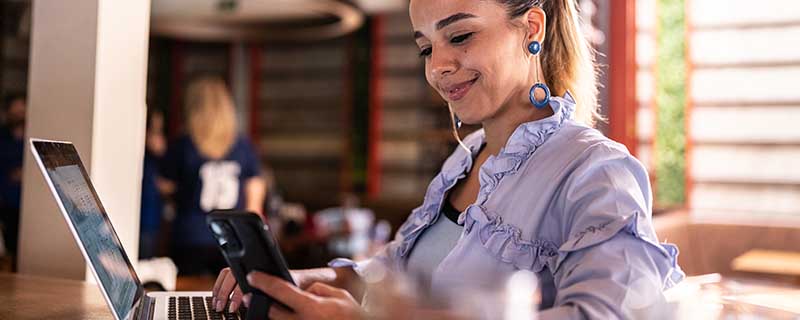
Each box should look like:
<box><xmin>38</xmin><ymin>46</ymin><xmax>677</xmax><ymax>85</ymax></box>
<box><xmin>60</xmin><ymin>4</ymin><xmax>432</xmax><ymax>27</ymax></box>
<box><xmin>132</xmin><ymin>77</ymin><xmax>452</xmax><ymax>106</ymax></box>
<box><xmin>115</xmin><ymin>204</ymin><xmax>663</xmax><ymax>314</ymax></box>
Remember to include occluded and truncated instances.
<box><xmin>0</xmin><ymin>94</ymin><xmax>26</xmax><ymax>264</ymax></box>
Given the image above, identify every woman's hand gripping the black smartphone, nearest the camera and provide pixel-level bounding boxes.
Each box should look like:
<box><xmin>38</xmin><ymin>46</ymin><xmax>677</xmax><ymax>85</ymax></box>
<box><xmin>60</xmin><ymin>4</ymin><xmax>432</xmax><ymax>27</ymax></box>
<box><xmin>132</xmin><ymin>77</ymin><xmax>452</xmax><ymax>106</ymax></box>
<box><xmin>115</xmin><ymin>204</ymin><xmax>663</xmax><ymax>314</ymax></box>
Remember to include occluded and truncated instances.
<box><xmin>244</xmin><ymin>272</ymin><xmax>363</xmax><ymax>320</ymax></box>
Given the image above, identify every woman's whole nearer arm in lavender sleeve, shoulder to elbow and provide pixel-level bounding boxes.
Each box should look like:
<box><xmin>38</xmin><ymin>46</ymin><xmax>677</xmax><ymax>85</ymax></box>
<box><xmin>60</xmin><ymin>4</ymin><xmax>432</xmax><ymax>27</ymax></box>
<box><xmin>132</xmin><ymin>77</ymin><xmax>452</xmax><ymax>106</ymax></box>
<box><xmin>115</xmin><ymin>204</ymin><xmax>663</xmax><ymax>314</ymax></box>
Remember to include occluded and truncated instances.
<box><xmin>540</xmin><ymin>146</ymin><xmax>683</xmax><ymax>319</ymax></box>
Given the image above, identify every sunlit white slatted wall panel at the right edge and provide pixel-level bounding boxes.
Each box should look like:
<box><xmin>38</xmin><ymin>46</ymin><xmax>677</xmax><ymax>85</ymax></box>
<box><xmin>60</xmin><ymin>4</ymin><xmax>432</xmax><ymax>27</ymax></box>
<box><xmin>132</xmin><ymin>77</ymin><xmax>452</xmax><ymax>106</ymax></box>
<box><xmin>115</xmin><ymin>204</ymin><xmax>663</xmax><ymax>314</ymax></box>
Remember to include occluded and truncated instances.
<box><xmin>687</xmin><ymin>0</ymin><xmax>800</xmax><ymax>223</ymax></box>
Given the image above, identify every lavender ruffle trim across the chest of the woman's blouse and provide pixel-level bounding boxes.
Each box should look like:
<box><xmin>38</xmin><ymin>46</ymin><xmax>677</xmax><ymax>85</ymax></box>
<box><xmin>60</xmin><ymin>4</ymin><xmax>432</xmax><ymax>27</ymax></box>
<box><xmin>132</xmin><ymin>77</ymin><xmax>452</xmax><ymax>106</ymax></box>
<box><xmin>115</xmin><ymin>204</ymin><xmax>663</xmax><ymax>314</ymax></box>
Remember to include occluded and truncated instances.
<box><xmin>464</xmin><ymin>206</ymin><xmax>558</xmax><ymax>272</ymax></box>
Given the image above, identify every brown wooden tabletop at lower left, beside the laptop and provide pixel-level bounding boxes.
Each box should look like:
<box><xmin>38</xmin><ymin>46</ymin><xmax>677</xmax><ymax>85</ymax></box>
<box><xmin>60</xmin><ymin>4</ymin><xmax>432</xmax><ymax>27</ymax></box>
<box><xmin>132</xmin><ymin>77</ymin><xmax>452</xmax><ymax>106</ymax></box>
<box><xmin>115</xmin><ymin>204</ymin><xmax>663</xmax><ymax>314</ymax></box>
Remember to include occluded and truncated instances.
<box><xmin>0</xmin><ymin>273</ymin><xmax>114</xmax><ymax>320</ymax></box>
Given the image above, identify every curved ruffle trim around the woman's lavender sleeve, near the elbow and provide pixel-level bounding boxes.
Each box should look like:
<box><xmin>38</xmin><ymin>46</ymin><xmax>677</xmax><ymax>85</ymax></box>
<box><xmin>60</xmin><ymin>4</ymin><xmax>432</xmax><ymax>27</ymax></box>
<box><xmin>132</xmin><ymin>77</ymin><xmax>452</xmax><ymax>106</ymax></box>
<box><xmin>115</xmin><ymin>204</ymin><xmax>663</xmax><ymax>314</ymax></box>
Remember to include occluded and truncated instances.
<box><xmin>548</xmin><ymin>211</ymin><xmax>684</xmax><ymax>289</ymax></box>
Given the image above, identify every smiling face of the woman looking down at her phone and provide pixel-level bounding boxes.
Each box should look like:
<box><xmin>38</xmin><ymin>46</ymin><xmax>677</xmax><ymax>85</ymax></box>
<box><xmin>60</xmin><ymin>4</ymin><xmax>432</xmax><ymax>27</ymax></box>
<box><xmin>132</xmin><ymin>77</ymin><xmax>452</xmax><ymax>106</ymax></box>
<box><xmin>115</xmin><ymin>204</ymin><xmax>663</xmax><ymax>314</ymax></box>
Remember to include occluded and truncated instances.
<box><xmin>409</xmin><ymin>0</ymin><xmax>533</xmax><ymax>124</ymax></box>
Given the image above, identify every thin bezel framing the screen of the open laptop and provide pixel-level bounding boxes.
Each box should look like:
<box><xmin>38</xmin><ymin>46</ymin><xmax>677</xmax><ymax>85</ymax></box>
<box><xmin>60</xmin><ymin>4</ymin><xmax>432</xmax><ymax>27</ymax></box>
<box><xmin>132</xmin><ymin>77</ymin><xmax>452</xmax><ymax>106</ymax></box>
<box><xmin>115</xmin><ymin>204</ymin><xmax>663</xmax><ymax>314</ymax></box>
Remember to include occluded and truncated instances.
<box><xmin>29</xmin><ymin>138</ymin><xmax>145</xmax><ymax>320</ymax></box>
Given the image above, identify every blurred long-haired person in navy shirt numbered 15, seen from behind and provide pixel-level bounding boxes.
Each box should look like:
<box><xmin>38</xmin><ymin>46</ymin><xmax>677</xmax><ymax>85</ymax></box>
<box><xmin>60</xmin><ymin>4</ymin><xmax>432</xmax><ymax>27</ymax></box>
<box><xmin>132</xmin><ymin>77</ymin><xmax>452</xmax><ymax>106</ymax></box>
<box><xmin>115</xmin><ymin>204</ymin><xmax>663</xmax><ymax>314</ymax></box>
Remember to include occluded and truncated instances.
<box><xmin>160</xmin><ymin>78</ymin><xmax>265</xmax><ymax>275</ymax></box>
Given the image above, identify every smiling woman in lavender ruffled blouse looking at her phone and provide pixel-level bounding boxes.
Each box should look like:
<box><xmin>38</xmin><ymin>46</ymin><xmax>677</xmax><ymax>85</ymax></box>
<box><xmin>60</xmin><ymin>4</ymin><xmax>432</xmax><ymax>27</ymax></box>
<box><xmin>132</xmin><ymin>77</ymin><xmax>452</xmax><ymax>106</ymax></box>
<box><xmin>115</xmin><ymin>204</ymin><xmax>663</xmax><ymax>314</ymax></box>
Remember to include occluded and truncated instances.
<box><xmin>214</xmin><ymin>0</ymin><xmax>683</xmax><ymax>319</ymax></box>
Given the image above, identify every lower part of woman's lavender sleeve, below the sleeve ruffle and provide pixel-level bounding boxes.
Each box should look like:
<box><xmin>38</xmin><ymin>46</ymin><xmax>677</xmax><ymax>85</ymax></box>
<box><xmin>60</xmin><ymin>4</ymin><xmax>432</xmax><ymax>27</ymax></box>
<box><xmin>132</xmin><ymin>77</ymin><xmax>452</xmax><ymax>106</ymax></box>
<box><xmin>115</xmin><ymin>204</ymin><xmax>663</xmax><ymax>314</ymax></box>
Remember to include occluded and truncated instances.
<box><xmin>539</xmin><ymin>232</ymin><xmax>668</xmax><ymax>320</ymax></box>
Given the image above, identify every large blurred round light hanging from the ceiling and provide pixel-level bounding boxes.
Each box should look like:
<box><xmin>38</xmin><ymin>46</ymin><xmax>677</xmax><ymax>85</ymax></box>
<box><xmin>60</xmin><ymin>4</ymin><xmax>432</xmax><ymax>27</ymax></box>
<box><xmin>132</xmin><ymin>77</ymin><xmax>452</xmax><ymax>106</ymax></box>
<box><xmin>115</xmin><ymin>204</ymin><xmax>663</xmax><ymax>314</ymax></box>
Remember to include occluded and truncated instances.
<box><xmin>151</xmin><ymin>0</ymin><xmax>364</xmax><ymax>41</ymax></box>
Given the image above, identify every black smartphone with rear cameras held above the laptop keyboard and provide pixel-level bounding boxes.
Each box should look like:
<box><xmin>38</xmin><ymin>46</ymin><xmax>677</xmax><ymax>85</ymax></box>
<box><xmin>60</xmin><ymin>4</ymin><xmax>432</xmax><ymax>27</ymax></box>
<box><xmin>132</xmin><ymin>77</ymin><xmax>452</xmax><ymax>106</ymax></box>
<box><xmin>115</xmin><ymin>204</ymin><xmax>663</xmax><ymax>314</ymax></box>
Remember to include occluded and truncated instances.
<box><xmin>206</xmin><ymin>210</ymin><xmax>295</xmax><ymax>319</ymax></box>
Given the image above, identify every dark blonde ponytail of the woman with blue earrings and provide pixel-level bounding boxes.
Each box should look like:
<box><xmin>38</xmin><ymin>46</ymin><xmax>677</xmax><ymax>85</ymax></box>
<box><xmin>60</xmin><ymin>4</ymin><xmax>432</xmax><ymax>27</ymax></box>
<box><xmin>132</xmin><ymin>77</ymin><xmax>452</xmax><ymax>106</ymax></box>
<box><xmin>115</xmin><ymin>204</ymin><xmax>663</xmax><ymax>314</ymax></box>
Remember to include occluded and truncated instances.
<box><xmin>495</xmin><ymin>0</ymin><xmax>601</xmax><ymax>126</ymax></box>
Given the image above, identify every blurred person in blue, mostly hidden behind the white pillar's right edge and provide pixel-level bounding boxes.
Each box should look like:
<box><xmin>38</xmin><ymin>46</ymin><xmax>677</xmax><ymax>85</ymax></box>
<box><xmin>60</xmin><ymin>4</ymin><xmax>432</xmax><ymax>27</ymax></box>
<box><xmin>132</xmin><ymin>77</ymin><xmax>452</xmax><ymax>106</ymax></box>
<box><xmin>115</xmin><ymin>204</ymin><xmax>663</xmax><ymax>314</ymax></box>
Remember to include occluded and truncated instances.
<box><xmin>139</xmin><ymin>110</ymin><xmax>167</xmax><ymax>259</ymax></box>
